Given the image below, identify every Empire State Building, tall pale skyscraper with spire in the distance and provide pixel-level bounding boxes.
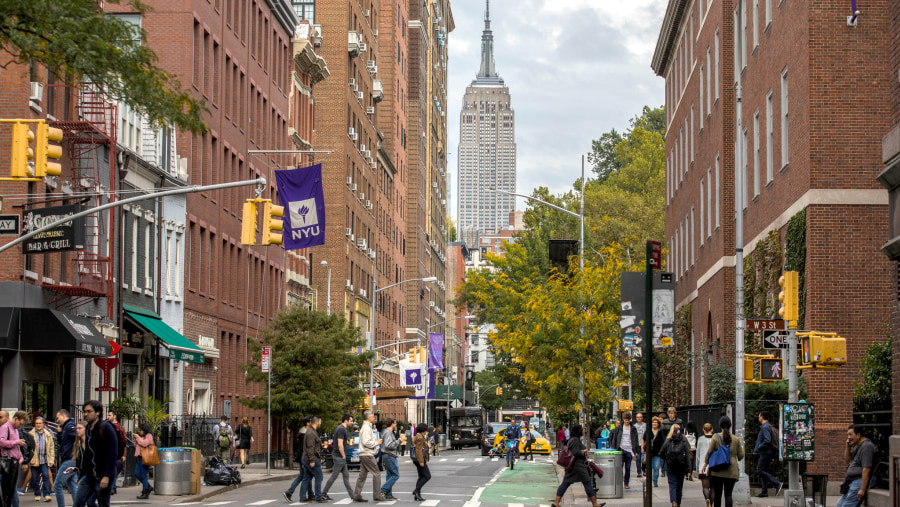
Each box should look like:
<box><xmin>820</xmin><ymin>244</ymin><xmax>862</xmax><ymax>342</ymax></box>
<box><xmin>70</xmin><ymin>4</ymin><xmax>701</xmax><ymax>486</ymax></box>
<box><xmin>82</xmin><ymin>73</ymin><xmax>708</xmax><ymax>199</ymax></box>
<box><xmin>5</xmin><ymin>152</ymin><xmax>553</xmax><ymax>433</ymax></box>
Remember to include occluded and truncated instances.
<box><xmin>457</xmin><ymin>0</ymin><xmax>516</xmax><ymax>248</ymax></box>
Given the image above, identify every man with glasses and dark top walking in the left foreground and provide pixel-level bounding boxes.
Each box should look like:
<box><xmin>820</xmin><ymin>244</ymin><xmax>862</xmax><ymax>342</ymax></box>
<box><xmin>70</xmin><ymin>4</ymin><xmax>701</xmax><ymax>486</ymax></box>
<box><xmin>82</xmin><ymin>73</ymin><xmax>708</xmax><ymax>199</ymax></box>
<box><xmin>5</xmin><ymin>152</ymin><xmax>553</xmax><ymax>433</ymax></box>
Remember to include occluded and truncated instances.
<box><xmin>75</xmin><ymin>400</ymin><xmax>119</xmax><ymax>507</ymax></box>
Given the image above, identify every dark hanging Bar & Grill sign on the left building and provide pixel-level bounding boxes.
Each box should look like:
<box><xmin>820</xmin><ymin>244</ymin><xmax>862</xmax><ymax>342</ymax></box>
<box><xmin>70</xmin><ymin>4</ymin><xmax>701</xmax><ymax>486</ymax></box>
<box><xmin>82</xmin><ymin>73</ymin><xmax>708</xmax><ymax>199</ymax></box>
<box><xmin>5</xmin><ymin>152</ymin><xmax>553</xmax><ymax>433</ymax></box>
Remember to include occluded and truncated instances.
<box><xmin>22</xmin><ymin>204</ymin><xmax>84</xmax><ymax>254</ymax></box>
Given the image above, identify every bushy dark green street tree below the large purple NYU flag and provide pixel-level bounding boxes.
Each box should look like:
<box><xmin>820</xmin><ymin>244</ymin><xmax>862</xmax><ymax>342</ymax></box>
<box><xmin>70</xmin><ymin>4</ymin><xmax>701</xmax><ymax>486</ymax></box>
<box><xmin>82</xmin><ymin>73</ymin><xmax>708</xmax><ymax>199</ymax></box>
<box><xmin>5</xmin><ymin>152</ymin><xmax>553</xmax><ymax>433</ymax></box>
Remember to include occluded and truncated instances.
<box><xmin>240</xmin><ymin>305</ymin><xmax>369</xmax><ymax>428</ymax></box>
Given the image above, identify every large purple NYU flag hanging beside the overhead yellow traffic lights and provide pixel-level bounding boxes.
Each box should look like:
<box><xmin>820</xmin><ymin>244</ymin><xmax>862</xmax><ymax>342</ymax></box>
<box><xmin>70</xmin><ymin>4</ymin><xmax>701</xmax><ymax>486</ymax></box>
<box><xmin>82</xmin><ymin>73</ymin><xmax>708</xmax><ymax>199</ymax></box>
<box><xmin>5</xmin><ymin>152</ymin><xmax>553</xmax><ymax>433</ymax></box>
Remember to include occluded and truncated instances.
<box><xmin>275</xmin><ymin>164</ymin><xmax>325</xmax><ymax>250</ymax></box>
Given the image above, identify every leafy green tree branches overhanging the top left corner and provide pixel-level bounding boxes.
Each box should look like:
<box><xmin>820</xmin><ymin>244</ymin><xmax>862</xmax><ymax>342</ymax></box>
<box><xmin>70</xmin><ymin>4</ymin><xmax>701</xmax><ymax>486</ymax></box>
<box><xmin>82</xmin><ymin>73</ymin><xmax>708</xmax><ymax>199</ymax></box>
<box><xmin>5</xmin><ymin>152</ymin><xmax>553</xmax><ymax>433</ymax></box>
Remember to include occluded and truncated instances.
<box><xmin>0</xmin><ymin>0</ymin><xmax>207</xmax><ymax>132</ymax></box>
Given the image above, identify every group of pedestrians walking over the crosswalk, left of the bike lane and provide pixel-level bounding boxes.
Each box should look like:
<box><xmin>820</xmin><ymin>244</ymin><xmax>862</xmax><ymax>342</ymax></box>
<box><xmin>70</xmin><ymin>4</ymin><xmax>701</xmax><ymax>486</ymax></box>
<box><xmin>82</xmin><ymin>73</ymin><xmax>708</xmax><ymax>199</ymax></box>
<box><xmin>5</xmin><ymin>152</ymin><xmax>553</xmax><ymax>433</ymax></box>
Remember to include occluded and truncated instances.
<box><xmin>283</xmin><ymin>410</ymin><xmax>431</xmax><ymax>503</ymax></box>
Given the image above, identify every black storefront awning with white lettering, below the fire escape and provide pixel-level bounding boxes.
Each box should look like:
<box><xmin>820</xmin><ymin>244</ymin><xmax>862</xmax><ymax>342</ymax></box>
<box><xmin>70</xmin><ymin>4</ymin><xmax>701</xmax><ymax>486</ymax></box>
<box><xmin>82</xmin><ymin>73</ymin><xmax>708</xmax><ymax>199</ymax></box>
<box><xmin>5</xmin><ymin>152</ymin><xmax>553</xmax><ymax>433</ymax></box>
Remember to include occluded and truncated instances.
<box><xmin>19</xmin><ymin>308</ymin><xmax>112</xmax><ymax>357</ymax></box>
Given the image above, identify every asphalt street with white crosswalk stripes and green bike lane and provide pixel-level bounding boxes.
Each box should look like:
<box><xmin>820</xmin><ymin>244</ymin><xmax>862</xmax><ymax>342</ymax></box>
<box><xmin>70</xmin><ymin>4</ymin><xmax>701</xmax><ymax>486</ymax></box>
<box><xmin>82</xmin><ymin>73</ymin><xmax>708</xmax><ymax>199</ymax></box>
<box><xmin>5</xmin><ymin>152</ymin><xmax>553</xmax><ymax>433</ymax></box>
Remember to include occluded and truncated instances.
<box><xmin>179</xmin><ymin>448</ymin><xmax>556</xmax><ymax>507</ymax></box>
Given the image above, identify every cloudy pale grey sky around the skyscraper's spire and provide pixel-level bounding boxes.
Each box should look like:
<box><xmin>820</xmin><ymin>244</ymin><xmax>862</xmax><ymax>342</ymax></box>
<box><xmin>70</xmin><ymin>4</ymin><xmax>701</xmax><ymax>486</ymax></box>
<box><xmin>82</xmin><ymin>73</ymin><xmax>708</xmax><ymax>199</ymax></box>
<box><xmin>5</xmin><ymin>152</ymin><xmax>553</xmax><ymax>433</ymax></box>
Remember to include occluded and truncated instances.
<box><xmin>447</xmin><ymin>0</ymin><xmax>667</xmax><ymax>217</ymax></box>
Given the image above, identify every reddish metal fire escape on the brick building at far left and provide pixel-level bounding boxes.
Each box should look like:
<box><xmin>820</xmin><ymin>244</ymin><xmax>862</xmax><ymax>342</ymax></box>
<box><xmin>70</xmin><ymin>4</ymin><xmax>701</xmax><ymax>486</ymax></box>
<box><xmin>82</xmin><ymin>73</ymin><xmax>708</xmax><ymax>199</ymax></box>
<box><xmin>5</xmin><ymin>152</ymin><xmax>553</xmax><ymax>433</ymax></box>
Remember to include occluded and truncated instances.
<box><xmin>42</xmin><ymin>84</ymin><xmax>118</xmax><ymax>316</ymax></box>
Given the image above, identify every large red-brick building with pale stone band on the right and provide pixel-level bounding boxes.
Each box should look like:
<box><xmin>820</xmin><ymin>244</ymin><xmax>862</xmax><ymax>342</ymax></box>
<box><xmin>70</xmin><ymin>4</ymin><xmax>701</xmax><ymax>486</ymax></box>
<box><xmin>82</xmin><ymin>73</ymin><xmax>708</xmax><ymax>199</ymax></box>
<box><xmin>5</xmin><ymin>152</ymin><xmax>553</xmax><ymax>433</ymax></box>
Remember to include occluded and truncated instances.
<box><xmin>652</xmin><ymin>0</ymin><xmax>892</xmax><ymax>484</ymax></box>
